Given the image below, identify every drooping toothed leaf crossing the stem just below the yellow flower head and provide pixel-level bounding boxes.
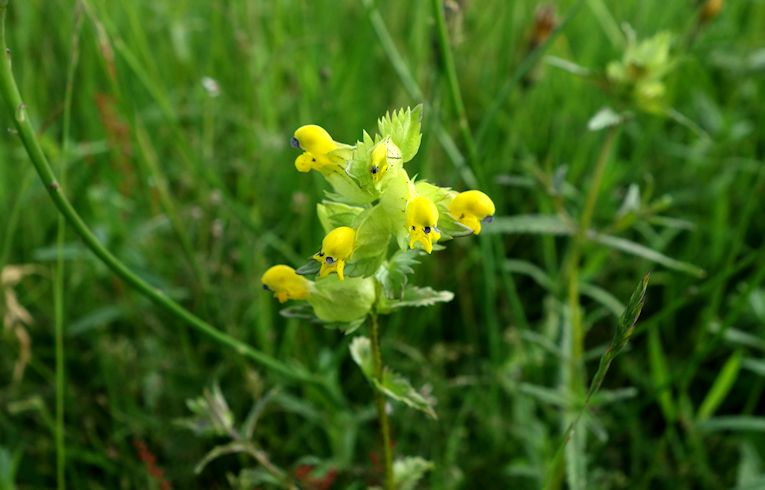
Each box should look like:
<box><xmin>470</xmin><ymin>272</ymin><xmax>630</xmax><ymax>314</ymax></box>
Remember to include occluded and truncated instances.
<box><xmin>350</xmin><ymin>337</ymin><xmax>438</xmax><ymax>419</ymax></box>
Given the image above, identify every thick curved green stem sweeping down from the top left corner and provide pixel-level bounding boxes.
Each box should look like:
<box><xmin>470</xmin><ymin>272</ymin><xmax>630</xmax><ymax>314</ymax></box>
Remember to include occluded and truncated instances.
<box><xmin>0</xmin><ymin>0</ymin><xmax>326</xmax><ymax>385</ymax></box>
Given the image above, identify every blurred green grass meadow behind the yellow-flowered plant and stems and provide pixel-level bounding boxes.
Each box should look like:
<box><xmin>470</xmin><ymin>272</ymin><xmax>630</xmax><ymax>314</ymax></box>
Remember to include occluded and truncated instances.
<box><xmin>0</xmin><ymin>0</ymin><xmax>765</xmax><ymax>489</ymax></box>
